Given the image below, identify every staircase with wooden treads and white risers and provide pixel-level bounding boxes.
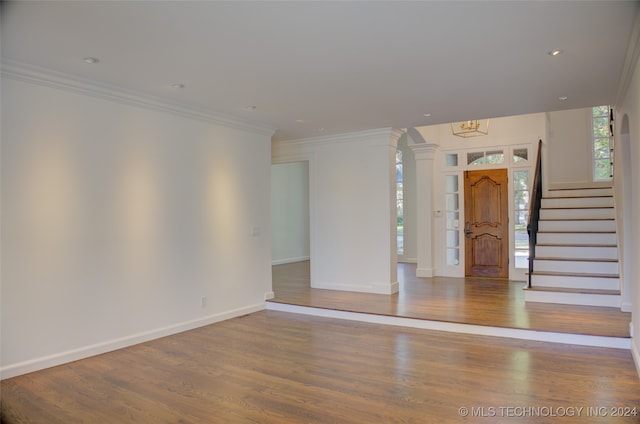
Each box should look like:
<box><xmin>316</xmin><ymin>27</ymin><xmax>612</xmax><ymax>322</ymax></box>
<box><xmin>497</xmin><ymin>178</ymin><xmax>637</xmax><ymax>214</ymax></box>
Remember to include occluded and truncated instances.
<box><xmin>525</xmin><ymin>188</ymin><xmax>621</xmax><ymax>307</ymax></box>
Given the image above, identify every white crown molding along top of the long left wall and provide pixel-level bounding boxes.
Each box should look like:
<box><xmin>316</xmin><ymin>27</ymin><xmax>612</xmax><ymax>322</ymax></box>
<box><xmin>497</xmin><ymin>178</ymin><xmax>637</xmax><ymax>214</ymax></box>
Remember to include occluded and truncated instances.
<box><xmin>0</xmin><ymin>60</ymin><xmax>276</xmax><ymax>137</ymax></box>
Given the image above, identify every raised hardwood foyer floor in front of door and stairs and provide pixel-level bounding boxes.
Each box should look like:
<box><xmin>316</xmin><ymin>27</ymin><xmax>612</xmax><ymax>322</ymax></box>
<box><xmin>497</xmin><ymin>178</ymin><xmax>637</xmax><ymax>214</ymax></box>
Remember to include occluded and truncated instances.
<box><xmin>271</xmin><ymin>261</ymin><xmax>631</xmax><ymax>337</ymax></box>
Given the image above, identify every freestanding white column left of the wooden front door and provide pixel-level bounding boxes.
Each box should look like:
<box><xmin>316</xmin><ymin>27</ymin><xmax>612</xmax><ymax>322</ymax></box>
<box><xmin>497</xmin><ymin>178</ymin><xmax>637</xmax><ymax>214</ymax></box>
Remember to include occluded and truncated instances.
<box><xmin>410</xmin><ymin>144</ymin><xmax>438</xmax><ymax>277</ymax></box>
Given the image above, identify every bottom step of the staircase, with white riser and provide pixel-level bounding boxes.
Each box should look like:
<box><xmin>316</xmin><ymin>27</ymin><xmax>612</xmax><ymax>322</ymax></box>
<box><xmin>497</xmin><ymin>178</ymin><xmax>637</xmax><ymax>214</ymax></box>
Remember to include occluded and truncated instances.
<box><xmin>524</xmin><ymin>287</ymin><xmax>620</xmax><ymax>308</ymax></box>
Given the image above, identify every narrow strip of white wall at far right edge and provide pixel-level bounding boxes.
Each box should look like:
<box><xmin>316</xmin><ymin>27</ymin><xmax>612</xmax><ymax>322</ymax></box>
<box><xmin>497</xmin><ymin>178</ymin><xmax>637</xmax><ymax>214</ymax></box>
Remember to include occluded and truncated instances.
<box><xmin>615</xmin><ymin>48</ymin><xmax>640</xmax><ymax>372</ymax></box>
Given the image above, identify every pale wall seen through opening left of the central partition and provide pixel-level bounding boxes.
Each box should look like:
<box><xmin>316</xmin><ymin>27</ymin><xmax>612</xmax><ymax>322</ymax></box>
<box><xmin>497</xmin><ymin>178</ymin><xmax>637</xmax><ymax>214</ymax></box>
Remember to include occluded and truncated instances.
<box><xmin>271</xmin><ymin>161</ymin><xmax>309</xmax><ymax>265</ymax></box>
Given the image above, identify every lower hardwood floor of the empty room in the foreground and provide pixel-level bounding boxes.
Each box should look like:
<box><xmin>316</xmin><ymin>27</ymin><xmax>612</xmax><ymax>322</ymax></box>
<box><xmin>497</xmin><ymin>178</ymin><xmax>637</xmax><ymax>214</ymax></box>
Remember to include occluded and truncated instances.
<box><xmin>1</xmin><ymin>311</ymin><xmax>640</xmax><ymax>424</ymax></box>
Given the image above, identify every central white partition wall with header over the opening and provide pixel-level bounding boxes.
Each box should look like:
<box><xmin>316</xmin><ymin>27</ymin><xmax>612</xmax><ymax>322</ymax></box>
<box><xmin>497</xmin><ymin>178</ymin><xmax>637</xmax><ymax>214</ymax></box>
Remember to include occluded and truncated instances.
<box><xmin>273</xmin><ymin>129</ymin><xmax>400</xmax><ymax>293</ymax></box>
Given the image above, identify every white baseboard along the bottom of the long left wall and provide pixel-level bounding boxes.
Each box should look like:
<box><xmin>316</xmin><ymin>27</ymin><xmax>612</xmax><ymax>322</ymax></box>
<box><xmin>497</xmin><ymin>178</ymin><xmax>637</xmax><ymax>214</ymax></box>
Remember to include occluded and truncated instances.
<box><xmin>0</xmin><ymin>303</ymin><xmax>266</xmax><ymax>380</ymax></box>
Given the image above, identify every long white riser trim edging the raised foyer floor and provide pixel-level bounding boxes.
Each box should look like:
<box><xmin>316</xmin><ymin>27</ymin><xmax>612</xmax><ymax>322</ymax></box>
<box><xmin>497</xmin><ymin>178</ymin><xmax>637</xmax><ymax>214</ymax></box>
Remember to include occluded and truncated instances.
<box><xmin>267</xmin><ymin>302</ymin><xmax>640</xmax><ymax>350</ymax></box>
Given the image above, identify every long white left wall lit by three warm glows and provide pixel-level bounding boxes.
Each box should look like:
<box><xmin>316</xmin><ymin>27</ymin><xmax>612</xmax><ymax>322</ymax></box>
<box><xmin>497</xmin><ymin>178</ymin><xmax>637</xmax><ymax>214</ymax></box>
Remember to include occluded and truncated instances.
<box><xmin>1</xmin><ymin>74</ymin><xmax>271</xmax><ymax>377</ymax></box>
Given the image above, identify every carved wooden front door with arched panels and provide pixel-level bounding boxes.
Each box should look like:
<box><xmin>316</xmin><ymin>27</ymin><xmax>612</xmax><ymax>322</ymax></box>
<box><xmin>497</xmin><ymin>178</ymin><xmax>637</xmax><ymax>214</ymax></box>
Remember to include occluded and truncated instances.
<box><xmin>464</xmin><ymin>169</ymin><xmax>509</xmax><ymax>278</ymax></box>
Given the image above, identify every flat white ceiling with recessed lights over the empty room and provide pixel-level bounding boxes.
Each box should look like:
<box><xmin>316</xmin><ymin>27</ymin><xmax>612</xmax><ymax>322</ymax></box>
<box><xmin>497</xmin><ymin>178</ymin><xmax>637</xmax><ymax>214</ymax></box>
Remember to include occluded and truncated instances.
<box><xmin>1</xmin><ymin>1</ymin><xmax>638</xmax><ymax>139</ymax></box>
